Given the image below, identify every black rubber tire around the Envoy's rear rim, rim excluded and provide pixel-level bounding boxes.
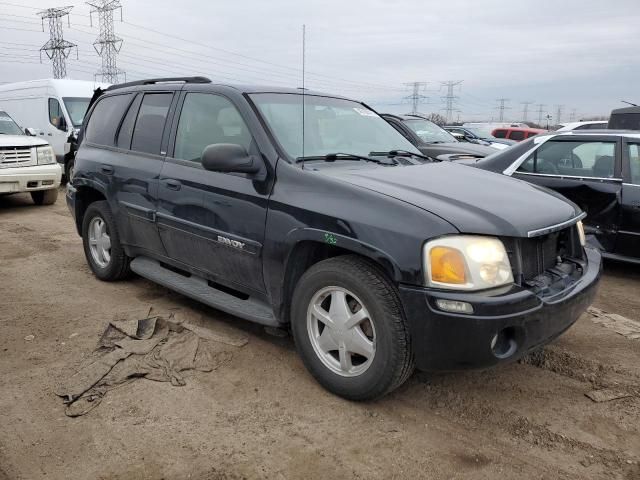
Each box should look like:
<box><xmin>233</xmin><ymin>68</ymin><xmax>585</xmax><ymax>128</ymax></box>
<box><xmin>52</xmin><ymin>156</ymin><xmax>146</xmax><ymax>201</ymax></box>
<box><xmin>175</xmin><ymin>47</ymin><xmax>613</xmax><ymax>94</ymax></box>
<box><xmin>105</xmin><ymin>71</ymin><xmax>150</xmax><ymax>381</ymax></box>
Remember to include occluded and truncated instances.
<box><xmin>82</xmin><ymin>200</ymin><xmax>131</xmax><ymax>282</ymax></box>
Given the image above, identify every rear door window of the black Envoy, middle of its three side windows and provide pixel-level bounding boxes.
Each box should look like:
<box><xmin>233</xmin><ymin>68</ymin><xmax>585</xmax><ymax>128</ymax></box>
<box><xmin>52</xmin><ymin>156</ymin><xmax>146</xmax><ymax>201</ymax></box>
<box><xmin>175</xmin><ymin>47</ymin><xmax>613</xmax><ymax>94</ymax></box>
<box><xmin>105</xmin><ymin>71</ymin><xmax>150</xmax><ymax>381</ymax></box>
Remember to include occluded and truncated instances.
<box><xmin>131</xmin><ymin>93</ymin><xmax>173</xmax><ymax>155</ymax></box>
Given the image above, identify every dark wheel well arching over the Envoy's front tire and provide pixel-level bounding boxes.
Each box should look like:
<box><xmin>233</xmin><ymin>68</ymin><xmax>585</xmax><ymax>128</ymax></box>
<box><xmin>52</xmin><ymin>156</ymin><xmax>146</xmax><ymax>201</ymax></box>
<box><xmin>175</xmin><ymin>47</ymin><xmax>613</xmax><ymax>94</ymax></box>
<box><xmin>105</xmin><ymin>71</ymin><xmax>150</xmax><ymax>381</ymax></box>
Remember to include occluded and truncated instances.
<box><xmin>280</xmin><ymin>240</ymin><xmax>393</xmax><ymax>323</ymax></box>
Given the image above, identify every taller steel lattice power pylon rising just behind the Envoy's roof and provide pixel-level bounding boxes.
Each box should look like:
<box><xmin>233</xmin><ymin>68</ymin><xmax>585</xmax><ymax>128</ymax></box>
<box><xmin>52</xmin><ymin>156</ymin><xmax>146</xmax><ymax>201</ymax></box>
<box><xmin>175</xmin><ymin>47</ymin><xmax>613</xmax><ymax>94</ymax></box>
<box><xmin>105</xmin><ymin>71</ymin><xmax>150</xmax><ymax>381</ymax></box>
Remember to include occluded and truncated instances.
<box><xmin>87</xmin><ymin>0</ymin><xmax>126</xmax><ymax>83</ymax></box>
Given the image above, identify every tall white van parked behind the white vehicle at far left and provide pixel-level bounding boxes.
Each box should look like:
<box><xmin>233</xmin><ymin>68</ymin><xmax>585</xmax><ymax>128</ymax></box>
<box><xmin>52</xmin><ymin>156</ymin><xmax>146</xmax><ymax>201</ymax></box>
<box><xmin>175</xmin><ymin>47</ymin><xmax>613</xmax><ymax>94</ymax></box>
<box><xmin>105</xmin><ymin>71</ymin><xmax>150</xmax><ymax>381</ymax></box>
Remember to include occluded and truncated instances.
<box><xmin>0</xmin><ymin>79</ymin><xmax>109</xmax><ymax>180</ymax></box>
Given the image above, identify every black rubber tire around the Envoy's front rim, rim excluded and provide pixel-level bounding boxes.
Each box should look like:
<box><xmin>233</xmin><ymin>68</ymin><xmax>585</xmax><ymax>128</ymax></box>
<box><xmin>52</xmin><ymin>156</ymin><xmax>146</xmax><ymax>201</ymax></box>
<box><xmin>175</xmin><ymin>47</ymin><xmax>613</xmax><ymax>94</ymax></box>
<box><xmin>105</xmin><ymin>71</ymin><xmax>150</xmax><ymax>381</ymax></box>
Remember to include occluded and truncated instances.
<box><xmin>291</xmin><ymin>255</ymin><xmax>414</xmax><ymax>400</ymax></box>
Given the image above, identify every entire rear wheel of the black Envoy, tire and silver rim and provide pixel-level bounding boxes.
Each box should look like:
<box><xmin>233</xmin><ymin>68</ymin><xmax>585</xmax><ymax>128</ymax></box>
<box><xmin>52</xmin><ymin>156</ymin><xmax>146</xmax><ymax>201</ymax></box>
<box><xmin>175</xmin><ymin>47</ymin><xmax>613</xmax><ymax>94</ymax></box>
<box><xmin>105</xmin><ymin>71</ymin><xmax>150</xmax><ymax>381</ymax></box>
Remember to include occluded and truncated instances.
<box><xmin>82</xmin><ymin>201</ymin><xmax>131</xmax><ymax>281</ymax></box>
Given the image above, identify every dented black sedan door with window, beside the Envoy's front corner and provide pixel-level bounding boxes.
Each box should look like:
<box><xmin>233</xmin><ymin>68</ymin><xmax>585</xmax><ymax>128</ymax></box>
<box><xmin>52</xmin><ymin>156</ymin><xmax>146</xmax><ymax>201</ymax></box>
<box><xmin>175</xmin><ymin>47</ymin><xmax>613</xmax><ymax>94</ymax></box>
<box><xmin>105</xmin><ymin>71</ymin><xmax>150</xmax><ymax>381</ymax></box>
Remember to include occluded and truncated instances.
<box><xmin>513</xmin><ymin>135</ymin><xmax>622</xmax><ymax>252</ymax></box>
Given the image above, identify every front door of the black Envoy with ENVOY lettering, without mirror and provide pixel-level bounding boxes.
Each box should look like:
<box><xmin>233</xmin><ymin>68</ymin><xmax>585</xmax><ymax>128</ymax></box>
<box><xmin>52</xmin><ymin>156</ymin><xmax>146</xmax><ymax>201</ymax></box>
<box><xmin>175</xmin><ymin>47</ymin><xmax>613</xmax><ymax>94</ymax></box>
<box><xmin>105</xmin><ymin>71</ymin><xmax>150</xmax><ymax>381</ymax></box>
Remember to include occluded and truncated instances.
<box><xmin>158</xmin><ymin>91</ymin><xmax>270</xmax><ymax>293</ymax></box>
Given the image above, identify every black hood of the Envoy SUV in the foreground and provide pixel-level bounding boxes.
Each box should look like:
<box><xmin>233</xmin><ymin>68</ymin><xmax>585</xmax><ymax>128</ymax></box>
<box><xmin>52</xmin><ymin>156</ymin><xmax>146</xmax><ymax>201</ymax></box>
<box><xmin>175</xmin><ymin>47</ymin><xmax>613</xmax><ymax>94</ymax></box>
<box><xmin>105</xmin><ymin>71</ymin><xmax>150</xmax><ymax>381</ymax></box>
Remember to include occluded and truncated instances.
<box><xmin>323</xmin><ymin>162</ymin><xmax>581</xmax><ymax>237</ymax></box>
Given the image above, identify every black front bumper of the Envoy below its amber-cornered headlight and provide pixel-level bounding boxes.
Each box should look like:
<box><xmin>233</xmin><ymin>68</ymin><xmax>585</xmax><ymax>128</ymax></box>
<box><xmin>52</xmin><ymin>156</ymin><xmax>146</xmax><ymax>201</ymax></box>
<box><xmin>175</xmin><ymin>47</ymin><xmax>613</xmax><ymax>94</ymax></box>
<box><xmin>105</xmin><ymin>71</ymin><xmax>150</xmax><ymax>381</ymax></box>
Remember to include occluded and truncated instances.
<box><xmin>400</xmin><ymin>247</ymin><xmax>602</xmax><ymax>370</ymax></box>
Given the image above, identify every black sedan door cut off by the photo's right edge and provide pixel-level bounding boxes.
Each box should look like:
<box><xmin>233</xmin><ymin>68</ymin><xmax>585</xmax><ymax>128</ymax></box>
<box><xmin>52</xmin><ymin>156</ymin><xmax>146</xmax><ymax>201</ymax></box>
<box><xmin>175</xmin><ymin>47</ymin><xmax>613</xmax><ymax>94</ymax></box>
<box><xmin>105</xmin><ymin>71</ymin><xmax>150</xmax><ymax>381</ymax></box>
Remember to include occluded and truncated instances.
<box><xmin>616</xmin><ymin>139</ymin><xmax>640</xmax><ymax>261</ymax></box>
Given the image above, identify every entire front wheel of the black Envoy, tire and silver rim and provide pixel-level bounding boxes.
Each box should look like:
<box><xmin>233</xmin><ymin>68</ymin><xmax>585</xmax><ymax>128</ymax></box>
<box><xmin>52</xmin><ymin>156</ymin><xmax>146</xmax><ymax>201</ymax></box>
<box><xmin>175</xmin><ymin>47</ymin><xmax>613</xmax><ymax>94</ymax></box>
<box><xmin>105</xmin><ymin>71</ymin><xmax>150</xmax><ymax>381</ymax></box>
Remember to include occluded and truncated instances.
<box><xmin>291</xmin><ymin>255</ymin><xmax>413</xmax><ymax>400</ymax></box>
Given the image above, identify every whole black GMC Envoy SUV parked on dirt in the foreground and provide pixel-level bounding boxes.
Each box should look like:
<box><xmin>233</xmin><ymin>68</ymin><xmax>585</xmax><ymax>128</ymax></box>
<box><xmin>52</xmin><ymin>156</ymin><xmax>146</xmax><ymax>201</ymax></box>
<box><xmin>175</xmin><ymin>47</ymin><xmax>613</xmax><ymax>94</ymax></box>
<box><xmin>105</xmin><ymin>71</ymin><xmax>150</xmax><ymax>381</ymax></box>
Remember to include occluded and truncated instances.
<box><xmin>67</xmin><ymin>77</ymin><xmax>601</xmax><ymax>400</ymax></box>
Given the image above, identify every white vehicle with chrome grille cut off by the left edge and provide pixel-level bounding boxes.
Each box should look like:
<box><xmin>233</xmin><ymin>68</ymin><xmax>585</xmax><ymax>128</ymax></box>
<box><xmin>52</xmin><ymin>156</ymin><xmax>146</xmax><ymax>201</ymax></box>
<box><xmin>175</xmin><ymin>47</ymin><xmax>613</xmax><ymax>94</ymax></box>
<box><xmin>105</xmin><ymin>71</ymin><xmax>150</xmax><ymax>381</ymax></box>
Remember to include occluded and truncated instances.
<box><xmin>0</xmin><ymin>111</ymin><xmax>62</xmax><ymax>205</ymax></box>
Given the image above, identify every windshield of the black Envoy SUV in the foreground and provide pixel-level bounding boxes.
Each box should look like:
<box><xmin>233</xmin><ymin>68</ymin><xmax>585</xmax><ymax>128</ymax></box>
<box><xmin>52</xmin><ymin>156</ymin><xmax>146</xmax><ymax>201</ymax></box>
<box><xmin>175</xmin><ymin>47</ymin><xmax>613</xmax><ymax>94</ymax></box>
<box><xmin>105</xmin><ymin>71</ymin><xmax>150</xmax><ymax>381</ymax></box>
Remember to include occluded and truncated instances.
<box><xmin>250</xmin><ymin>93</ymin><xmax>420</xmax><ymax>158</ymax></box>
